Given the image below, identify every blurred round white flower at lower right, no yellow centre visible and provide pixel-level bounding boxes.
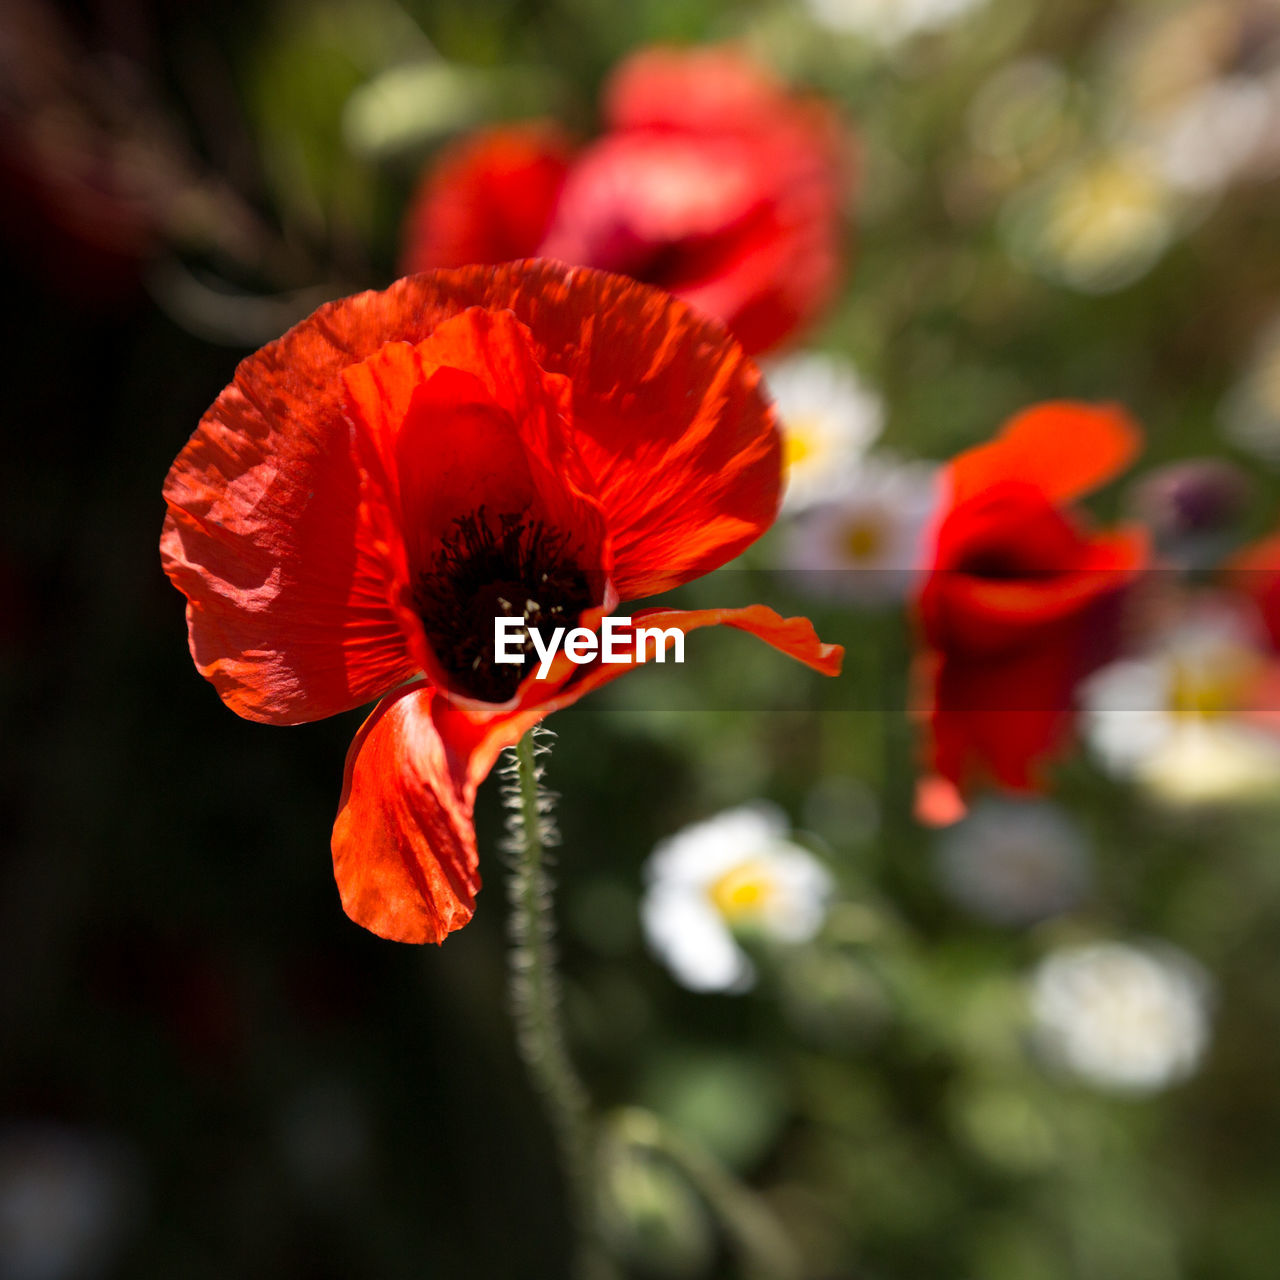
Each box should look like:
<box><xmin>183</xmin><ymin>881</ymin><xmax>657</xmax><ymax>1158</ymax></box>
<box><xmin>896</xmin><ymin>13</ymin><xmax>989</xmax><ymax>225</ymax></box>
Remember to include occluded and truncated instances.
<box><xmin>1030</xmin><ymin>942</ymin><xmax>1211</xmax><ymax>1093</ymax></box>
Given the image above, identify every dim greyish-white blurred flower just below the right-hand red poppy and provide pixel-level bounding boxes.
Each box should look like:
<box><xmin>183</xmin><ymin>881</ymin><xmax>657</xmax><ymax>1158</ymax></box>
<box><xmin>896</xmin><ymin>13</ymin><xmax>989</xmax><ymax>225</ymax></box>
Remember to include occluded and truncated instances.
<box><xmin>937</xmin><ymin>797</ymin><xmax>1092</xmax><ymax>924</ymax></box>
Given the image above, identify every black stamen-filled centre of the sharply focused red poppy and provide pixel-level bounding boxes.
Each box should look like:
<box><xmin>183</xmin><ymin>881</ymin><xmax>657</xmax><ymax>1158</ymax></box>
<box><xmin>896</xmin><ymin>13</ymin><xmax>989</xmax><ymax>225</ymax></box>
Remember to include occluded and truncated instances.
<box><xmin>413</xmin><ymin>507</ymin><xmax>595</xmax><ymax>703</ymax></box>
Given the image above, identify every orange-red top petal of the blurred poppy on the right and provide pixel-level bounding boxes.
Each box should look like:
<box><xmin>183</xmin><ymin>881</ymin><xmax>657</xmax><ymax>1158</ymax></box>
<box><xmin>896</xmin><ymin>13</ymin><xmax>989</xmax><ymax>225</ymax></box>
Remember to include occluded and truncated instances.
<box><xmin>947</xmin><ymin>401</ymin><xmax>1142</xmax><ymax>508</ymax></box>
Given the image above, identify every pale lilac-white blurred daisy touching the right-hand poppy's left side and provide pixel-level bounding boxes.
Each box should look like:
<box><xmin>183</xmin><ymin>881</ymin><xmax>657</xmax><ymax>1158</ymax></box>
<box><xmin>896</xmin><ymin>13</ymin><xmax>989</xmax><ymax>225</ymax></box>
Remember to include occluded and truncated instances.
<box><xmin>782</xmin><ymin>456</ymin><xmax>940</xmax><ymax>604</ymax></box>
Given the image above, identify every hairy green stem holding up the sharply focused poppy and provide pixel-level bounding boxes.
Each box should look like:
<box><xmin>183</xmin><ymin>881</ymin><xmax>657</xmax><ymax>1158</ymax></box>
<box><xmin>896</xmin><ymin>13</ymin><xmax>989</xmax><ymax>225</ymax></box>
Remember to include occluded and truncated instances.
<box><xmin>506</xmin><ymin>728</ymin><xmax>617</xmax><ymax>1280</ymax></box>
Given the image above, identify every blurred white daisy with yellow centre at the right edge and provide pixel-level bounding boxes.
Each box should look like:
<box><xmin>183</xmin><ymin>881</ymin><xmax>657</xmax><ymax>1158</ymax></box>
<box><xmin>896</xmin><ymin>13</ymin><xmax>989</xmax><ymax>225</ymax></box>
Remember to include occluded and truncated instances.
<box><xmin>1082</xmin><ymin>602</ymin><xmax>1280</xmax><ymax>805</ymax></box>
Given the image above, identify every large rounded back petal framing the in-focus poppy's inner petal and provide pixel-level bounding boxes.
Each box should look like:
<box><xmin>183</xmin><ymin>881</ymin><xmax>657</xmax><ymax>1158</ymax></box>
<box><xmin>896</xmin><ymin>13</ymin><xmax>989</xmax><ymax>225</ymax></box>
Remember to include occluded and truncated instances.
<box><xmin>161</xmin><ymin>262</ymin><xmax>781</xmax><ymax>723</ymax></box>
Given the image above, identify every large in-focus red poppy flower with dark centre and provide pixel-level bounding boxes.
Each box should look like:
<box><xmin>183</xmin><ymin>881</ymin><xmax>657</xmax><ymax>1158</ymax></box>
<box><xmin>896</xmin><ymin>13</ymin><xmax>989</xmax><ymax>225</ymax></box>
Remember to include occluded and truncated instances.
<box><xmin>161</xmin><ymin>262</ymin><xmax>841</xmax><ymax>942</ymax></box>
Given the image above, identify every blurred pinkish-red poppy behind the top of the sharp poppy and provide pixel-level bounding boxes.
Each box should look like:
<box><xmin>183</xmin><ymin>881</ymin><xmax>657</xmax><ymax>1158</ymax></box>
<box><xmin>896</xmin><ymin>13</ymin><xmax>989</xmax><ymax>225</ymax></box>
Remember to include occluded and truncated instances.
<box><xmin>404</xmin><ymin>49</ymin><xmax>846</xmax><ymax>352</ymax></box>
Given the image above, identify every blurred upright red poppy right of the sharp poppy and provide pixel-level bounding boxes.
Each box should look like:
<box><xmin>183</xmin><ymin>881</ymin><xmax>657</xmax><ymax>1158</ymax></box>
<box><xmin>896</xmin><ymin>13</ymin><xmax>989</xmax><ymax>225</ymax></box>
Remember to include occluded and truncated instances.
<box><xmin>919</xmin><ymin>402</ymin><xmax>1147</xmax><ymax>798</ymax></box>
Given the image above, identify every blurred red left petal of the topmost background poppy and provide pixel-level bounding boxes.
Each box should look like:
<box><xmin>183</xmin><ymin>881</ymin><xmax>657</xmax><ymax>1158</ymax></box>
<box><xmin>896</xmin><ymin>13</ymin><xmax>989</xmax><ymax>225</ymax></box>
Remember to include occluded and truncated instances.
<box><xmin>402</xmin><ymin>120</ymin><xmax>572</xmax><ymax>274</ymax></box>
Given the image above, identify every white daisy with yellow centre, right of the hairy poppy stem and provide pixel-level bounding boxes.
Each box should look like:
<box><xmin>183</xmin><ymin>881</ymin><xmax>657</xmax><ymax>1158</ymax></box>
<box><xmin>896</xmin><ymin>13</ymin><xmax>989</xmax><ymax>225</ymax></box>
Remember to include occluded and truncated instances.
<box><xmin>640</xmin><ymin>804</ymin><xmax>832</xmax><ymax>992</ymax></box>
